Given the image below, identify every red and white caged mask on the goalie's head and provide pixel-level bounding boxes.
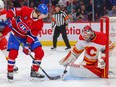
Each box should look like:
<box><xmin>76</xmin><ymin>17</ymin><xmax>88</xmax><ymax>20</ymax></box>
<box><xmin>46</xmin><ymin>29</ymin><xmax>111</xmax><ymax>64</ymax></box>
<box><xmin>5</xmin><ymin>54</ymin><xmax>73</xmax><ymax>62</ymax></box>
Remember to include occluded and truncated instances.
<box><xmin>82</xmin><ymin>25</ymin><xmax>94</xmax><ymax>42</ymax></box>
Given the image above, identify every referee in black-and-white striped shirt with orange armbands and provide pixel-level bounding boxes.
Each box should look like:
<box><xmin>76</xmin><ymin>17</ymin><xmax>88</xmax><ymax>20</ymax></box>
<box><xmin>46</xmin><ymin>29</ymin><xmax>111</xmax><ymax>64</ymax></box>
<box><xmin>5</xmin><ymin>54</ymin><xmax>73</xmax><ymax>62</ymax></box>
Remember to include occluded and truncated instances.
<box><xmin>51</xmin><ymin>4</ymin><xmax>71</xmax><ymax>50</ymax></box>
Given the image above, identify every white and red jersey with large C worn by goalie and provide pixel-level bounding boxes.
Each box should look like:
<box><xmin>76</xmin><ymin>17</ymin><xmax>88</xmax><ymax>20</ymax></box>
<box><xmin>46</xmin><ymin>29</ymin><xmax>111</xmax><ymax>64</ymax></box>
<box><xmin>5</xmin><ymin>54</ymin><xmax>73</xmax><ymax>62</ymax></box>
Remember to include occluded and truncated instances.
<box><xmin>72</xmin><ymin>32</ymin><xmax>107</xmax><ymax>60</ymax></box>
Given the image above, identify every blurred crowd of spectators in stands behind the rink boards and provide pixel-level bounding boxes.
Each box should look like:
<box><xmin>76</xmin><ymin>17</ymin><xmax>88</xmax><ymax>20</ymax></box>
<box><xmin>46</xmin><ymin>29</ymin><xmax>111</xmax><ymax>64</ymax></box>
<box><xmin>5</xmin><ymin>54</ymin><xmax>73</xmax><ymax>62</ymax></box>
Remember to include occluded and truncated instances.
<box><xmin>7</xmin><ymin>0</ymin><xmax>116</xmax><ymax>22</ymax></box>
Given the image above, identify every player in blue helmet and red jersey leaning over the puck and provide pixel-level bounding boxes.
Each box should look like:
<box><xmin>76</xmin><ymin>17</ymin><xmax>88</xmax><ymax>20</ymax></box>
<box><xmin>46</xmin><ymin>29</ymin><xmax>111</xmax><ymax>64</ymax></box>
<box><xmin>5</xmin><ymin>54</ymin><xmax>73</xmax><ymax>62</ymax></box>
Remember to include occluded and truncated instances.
<box><xmin>0</xmin><ymin>4</ymin><xmax>48</xmax><ymax>79</ymax></box>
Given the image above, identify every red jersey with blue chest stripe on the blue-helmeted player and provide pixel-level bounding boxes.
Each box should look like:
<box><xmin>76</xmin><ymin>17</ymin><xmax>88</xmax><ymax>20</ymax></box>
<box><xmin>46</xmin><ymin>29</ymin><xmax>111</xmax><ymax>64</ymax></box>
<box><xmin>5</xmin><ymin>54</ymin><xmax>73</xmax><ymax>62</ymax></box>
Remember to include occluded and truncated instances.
<box><xmin>7</xmin><ymin>6</ymin><xmax>43</xmax><ymax>43</ymax></box>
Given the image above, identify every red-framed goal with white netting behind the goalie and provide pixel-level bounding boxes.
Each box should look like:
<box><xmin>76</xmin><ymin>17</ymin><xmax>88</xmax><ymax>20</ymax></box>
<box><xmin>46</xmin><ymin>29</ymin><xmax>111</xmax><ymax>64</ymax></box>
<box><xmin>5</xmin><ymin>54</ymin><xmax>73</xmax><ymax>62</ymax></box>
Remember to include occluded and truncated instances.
<box><xmin>100</xmin><ymin>17</ymin><xmax>116</xmax><ymax>77</ymax></box>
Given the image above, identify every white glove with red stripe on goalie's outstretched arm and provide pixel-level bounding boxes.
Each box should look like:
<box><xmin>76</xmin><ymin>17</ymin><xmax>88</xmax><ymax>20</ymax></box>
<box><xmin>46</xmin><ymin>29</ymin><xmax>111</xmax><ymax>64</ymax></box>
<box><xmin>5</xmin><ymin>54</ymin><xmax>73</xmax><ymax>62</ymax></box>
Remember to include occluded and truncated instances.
<box><xmin>59</xmin><ymin>51</ymin><xmax>77</xmax><ymax>66</ymax></box>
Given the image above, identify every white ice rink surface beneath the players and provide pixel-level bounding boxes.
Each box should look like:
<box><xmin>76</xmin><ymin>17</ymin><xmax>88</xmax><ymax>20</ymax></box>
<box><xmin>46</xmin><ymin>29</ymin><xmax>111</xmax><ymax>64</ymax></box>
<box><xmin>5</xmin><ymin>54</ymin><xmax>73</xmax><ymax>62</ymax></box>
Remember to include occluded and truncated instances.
<box><xmin>0</xmin><ymin>47</ymin><xmax>116</xmax><ymax>87</ymax></box>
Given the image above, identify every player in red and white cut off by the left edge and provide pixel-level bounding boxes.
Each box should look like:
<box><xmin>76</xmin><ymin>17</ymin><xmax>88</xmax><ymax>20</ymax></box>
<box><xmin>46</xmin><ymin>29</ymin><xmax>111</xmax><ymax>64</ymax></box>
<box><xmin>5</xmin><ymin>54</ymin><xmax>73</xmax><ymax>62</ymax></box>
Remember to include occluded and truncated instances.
<box><xmin>0</xmin><ymin>0</ymin><xmax>18</xmax><ymax>71</ymax></box>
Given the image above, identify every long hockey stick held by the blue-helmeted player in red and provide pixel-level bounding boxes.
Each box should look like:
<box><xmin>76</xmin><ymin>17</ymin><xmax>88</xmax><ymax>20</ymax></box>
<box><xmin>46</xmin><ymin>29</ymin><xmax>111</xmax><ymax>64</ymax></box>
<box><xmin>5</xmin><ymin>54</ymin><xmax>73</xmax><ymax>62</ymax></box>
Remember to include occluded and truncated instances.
<box><xmin>11</xmin><ymin>32</ymin><xmax>61</xmax><ymax>80</ymax></box>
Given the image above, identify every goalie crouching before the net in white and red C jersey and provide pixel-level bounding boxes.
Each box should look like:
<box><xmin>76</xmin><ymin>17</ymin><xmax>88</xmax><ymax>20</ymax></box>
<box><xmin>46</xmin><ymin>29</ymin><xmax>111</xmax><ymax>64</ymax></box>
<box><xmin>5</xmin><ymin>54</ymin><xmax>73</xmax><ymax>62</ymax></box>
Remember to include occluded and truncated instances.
<box><xmin>59</xmin><ymin>25</ymin><xmax>107</xmax><ymax>78</ymax></box>
